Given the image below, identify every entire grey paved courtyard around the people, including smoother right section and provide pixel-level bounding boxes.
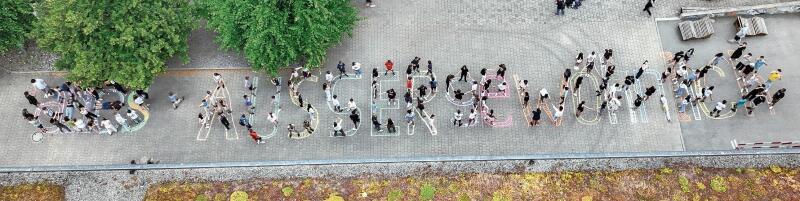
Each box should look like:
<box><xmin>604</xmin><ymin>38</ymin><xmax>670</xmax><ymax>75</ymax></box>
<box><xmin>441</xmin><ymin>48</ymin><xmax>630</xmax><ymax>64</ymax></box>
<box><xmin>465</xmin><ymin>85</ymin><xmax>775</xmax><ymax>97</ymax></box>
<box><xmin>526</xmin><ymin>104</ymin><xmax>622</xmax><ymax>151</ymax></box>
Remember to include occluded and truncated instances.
<box><xmin>0</xmin><ymin>0</ymin><xmax>800</xmax><ymax>166</ymax></box>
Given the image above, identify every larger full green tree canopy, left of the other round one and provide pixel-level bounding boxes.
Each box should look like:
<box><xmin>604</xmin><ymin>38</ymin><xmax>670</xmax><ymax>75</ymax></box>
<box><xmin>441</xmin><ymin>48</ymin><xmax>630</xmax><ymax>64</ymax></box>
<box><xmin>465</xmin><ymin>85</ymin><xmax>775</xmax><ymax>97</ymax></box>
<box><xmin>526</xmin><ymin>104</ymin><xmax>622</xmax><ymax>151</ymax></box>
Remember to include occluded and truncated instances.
<box><xmin>33</xmin><ymin>0</ymin><xmax>196</xmax><ymax>89</ymax></box>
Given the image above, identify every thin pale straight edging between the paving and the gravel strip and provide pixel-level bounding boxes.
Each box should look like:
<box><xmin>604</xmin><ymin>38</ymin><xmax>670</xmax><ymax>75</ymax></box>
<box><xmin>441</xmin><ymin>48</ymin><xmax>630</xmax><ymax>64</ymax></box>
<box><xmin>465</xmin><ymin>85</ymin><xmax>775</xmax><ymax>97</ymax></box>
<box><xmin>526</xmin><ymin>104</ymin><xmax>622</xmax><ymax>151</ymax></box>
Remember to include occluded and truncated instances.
<box><xmin>0</xmin><ymin>149</ymin><xmax>800</xmax><ymax>173</ymax></box>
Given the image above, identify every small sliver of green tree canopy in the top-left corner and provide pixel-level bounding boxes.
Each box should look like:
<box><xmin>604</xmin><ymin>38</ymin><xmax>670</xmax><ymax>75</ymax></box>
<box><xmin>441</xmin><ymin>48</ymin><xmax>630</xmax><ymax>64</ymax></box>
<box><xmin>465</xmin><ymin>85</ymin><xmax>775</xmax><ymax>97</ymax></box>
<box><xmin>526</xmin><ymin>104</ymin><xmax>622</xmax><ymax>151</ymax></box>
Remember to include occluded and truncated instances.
<box><xmin>0</xmin><ymin>0</ymin><xmax>36</xmax><ymax>54</ymax></box>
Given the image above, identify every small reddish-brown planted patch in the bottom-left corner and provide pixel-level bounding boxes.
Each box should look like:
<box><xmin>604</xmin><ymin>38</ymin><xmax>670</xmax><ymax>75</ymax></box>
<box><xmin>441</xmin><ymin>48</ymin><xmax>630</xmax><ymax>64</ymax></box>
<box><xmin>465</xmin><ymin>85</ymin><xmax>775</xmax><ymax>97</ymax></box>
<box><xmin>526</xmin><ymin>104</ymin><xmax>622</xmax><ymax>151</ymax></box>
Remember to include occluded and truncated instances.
<box><xmin>0</xmin><ymin>183</ymin><xmax>64</xmax><ymax>201</ymax></box>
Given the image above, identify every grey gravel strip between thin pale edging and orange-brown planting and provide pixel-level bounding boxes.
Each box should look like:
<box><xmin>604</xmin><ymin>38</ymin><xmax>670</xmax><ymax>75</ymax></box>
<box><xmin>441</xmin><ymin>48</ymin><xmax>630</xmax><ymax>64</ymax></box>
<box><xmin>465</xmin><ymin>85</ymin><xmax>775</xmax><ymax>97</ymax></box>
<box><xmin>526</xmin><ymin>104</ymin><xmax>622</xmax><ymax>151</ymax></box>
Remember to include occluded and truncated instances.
<box><xmin>0</xmin><ymin>154</ymin><xmax>800</xmax><ymax>200</ymax></box>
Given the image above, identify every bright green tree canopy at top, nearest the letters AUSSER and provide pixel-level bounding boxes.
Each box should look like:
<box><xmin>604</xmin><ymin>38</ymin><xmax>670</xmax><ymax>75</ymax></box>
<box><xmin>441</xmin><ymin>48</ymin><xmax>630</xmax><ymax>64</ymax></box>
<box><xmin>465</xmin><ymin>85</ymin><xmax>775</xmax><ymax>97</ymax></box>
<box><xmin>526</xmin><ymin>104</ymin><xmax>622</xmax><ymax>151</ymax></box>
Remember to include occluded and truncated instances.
<box><xmin>202</xmin><ymin>0</ymin><xmax>358</xmax><ymax>75</ymax></box>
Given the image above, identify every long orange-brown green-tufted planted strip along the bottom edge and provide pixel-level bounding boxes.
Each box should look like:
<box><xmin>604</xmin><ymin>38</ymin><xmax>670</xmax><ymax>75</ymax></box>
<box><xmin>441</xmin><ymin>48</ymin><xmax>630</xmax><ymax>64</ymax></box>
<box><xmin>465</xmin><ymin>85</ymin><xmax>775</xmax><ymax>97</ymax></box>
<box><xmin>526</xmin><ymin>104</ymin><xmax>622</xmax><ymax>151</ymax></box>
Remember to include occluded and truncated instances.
<box><xmin>146</xmin><ymin>166</ymin><xmax>800</xmax><ymax>201</ymax></box>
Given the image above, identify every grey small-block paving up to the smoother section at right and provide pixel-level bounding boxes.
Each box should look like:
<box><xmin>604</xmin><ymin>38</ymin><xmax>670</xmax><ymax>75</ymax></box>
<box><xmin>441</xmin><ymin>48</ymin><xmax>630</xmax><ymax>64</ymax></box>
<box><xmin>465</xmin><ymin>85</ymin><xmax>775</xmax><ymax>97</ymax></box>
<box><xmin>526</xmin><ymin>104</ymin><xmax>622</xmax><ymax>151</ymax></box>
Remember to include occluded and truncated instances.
<box><xmin>0</xmin><ymin>0</ymin><xmax>792</xmax><ymax>166</ymax></box>
